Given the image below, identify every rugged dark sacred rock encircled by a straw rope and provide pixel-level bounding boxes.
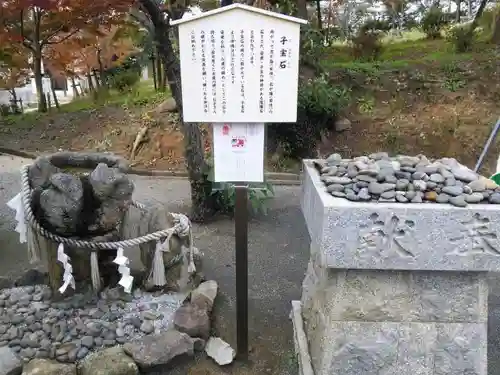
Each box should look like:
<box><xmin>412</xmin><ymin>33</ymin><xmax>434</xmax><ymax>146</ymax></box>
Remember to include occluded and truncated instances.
<box><xmin>21</xmin><ymin>152</ymin><xmax>203</xmax><ymax>292</ymax></box>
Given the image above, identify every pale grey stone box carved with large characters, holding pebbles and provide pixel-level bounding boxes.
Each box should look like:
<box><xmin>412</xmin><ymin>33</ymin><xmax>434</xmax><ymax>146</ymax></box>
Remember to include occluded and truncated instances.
<box><xmin>301</xmin><ymin>160</ymin><xmax>500</xmax><ymax>271</ymax></box>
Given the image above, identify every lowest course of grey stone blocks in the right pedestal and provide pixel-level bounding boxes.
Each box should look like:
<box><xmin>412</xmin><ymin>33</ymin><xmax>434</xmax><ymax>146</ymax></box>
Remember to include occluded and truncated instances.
<box><xmin>311</xmin><ymin>322</ymin><xmax>487</xmax><ymax>375</ymax></box>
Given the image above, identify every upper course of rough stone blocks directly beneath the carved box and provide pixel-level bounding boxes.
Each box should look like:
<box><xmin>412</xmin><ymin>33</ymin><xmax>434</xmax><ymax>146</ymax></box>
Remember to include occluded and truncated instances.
<box><xmin>302</xmin><ymin>267</ymin><xmax>488</xmax><ymax>323</ymax></box>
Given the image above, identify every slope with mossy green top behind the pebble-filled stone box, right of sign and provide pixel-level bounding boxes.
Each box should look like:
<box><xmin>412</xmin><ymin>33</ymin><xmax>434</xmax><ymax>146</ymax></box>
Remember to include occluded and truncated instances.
<box><xmin>316</xmin><ymin>32</ymin><xmax>500</xmax><ymax>173</ymax></box>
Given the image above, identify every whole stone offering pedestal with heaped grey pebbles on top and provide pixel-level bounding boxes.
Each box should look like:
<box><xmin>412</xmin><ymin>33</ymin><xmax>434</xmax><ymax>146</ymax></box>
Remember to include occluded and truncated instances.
<box><xmin>292</xmin><ymin>153</ymin><xmax>500</xmax><ymax>375</ymax></box>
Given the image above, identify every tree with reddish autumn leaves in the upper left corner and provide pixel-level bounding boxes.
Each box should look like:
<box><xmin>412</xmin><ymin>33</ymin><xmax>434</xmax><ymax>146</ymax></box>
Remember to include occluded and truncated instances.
<box><xmin>0</xmin><ymin>0</ymin><xmax>133</xmax><ymax>111</ymax></box>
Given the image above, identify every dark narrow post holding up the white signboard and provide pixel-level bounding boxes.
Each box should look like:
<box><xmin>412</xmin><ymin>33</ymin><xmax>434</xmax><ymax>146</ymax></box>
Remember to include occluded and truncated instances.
<box><xmin>234</xmin><ymin>186</ymin><xmax>248</xmax><ymax>360</ymax></box>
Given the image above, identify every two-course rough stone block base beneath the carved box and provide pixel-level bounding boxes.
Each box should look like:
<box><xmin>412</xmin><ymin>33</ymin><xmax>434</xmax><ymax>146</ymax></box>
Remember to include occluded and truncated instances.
<box><xmin>302</xmin><ymin>264</ymin><xmax>488</xmax><ymax>375</ymax></box>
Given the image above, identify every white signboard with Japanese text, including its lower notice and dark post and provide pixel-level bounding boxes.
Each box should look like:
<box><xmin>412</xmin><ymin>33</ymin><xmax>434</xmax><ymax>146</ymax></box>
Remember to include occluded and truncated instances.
<box><xmin>171</xmin><ymin>4</ymin><xmax>307</xmax><ymax>359</ymax></box>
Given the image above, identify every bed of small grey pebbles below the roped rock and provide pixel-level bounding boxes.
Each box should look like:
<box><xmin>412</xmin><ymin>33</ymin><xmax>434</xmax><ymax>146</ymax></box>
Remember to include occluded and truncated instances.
<box><xmin>0</xmin><ymin>285</ymin><xmax>182</xmax><ymax>364</ymax></box>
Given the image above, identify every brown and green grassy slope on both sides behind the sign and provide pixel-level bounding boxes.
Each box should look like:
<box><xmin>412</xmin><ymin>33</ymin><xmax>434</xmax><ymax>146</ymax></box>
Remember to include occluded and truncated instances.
<box><xmin>0</xmin><ymin>32</ymin><xmax>500</xmax><ymax>173</ymax></box>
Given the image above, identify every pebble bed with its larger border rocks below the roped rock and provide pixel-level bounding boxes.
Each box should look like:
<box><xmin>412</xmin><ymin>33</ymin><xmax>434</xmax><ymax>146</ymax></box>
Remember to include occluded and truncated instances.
<box><xmin>0</xmin><ymin>276</ymin><xmax>223</xmax><ymax>375</ymax></box>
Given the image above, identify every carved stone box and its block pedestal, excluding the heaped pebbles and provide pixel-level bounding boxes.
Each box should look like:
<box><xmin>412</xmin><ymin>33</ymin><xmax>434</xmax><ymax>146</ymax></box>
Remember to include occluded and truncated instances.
<box><xmin>301</xmin><ymin>160</ymin><xmax>500</xmax><ymax>375</ymax></box>
